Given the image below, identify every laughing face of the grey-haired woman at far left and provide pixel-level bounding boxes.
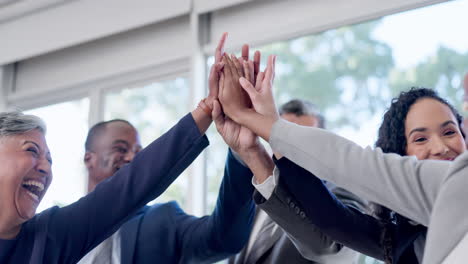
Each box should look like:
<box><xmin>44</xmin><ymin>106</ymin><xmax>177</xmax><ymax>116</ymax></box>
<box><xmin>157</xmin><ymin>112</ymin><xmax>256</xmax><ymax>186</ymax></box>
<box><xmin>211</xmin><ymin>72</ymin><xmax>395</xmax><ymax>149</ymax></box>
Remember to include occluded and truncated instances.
<box><xmin>0</xmin><ymin>130</ymin><xmax>52</xmax><ymax>224</ymax></box>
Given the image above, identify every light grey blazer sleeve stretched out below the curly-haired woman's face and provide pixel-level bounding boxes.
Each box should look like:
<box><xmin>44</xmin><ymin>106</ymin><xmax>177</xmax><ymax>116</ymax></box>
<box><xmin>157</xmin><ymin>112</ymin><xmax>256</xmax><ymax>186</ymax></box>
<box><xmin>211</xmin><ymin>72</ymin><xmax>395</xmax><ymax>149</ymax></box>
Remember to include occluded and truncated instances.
<box><xmin>270</xmin><ymin>119</ymin><xmax>450</xmax><ymax>226</ymax></box>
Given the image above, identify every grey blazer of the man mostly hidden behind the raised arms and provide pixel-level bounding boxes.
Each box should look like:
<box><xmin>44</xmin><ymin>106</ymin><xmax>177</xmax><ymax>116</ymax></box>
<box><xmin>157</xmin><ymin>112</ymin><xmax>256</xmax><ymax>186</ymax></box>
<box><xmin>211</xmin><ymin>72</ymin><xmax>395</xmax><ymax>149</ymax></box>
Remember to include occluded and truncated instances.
<box><xmin>228</xmin><ymin>184</ymin><xmax>365</xmax><ymax>264</ymax></box>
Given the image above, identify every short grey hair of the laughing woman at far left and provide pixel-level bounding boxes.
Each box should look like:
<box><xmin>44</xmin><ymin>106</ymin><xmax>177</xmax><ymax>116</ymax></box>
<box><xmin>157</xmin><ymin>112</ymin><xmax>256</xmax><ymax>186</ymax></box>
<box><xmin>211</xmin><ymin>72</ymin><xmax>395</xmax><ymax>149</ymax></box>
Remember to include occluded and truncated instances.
<box><xmin>0</xmin><ymin>111</ymin><xmax>47</xmax><ymax>137</ymax></box>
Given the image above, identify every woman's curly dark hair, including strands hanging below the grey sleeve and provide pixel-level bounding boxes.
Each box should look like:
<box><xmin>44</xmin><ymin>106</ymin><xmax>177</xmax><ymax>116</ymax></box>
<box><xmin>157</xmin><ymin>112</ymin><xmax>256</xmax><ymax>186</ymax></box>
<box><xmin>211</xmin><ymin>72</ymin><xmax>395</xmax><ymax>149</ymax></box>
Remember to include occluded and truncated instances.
<box><xmin>371</xmin><ymin>87</ymin><xmax>465</xmax><ymax>263</ymax></box>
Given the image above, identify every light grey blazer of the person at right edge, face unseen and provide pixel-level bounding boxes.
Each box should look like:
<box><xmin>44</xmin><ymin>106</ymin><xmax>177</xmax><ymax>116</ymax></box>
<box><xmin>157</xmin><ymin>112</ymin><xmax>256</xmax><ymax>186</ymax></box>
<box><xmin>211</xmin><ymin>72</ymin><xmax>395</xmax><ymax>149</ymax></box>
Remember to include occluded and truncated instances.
<box><xmin>269</xmin><ymin>119</ymin><xmax>468</xmax><ymax>264</ymax></box>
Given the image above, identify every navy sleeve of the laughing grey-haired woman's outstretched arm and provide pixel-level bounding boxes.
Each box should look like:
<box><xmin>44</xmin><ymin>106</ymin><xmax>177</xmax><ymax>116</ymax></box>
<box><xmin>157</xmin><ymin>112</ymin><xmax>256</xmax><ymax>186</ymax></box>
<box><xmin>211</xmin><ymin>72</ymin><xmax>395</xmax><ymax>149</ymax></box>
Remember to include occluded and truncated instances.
<box><xmin>49</xmin><ymin>114</ymin><xmax>208</xmax><ymax>263</ymax></box>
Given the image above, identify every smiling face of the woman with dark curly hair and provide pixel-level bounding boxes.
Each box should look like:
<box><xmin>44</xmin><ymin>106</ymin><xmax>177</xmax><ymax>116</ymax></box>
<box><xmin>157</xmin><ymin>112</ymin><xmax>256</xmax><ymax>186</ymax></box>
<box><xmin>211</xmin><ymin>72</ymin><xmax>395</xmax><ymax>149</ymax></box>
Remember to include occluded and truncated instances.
<box><xmin>405</xmin><ymin>98</ymin><xmax>466</xmax><ymax>160</ymax></box>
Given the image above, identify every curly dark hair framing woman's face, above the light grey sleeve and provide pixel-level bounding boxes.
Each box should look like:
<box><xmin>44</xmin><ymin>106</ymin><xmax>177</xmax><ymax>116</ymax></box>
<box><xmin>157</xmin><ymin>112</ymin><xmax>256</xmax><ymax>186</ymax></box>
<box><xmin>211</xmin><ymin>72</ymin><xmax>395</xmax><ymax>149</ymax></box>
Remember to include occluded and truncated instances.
<box><xmin>375</xmin><ymin>87</ymin><xmax>465</xmax><ymax>156</ymax></box>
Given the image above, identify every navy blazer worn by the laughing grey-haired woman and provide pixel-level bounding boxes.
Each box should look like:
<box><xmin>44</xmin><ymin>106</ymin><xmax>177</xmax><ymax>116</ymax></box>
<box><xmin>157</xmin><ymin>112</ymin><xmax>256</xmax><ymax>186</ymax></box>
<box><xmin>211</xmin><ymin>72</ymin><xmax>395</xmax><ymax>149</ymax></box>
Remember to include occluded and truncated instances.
<box><xmin>0</xmin><ymin>114</ymin><xmax>216</xmax><ymax>264</ymax></box>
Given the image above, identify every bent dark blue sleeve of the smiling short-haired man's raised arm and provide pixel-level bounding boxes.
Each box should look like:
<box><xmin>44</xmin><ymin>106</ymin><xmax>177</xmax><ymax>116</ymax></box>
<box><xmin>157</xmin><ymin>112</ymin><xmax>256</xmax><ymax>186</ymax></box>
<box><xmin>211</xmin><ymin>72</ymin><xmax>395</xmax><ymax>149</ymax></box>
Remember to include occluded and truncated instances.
<box><xmin>177</xmin><ymin>150</ymin><xmax>255</xmax><ymax>263</ymax></box>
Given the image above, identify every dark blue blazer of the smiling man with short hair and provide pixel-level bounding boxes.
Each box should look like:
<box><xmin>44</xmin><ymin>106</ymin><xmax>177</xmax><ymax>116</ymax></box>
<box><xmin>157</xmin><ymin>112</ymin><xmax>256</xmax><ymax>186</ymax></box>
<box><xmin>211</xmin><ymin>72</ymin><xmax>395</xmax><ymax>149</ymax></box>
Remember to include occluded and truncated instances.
<box><xmin>121</xmin><ymin>151</ymin><xmax>255</xmax><ymax>264</ymax></box>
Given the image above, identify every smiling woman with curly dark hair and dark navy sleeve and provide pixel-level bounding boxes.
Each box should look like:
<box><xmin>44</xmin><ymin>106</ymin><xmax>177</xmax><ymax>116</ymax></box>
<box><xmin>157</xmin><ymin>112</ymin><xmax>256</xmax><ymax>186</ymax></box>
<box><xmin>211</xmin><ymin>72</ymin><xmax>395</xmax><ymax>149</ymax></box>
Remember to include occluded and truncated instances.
<box><xmin>254</xmin><ymin>88</ymin><xmax>465</xmax><ymax>263</ymax></box>
